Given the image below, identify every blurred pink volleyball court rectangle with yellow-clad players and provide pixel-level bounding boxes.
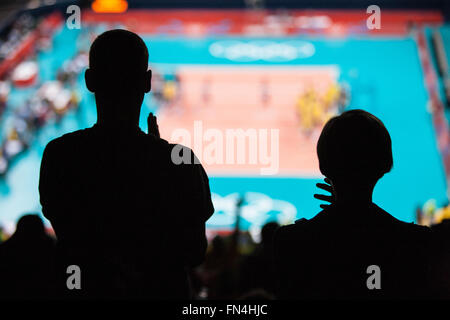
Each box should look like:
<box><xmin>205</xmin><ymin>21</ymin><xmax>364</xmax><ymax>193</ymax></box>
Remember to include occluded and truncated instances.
<box><xmin>158</xmin><ymin>65</ymin><xmax>340</xmax><ymax>176</ymax></box>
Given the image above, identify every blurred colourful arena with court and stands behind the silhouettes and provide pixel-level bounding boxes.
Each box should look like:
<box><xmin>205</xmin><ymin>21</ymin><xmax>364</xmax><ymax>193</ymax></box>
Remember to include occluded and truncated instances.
<box><xmin>0</xmin><ymin>0</ymin><xmax>450</xmax><ymax>250</ymax></box>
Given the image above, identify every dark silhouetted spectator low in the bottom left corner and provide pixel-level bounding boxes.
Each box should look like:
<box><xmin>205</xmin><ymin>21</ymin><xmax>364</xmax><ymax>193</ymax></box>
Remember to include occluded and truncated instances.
<box><xmin>0</xmin><ymin>214</ymin><xmax>55</xmax><ymax>299</ymax></box>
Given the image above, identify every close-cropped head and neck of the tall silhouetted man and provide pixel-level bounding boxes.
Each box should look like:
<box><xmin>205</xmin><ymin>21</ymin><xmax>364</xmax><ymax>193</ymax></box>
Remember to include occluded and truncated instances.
<box><xmin>85</xmin><ymin>29</ymin><xmax>152</xmax><ymax>128</ymax></box>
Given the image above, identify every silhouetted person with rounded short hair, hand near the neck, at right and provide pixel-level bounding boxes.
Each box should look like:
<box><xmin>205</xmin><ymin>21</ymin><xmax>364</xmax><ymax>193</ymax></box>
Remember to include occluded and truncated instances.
<box><xmin>274</xmin><ymin>110</ymin><xmax>431</xmax><ymax>299</ymax></box>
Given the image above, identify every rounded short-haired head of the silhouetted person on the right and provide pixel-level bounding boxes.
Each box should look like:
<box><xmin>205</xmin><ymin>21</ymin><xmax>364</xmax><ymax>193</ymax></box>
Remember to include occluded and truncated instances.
<box><xmin>317</xmin><ymin>110</ymin><xmax>393</xmax><ymax>185</ymax></box>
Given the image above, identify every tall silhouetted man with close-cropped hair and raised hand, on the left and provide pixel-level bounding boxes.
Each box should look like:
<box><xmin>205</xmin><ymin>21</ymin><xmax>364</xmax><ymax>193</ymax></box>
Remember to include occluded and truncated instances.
<box><xmin>39</xmin><ymin>30</ymin><xmax>214</xmax><ymax>299</ymax></box>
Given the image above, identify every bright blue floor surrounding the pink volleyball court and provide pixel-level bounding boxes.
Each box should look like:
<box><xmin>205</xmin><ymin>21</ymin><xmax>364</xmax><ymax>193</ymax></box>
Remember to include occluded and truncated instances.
<box><xmin>0</xmin><ymin>21</ymin><xmax>447</xmax><ymax>229</ymax></box>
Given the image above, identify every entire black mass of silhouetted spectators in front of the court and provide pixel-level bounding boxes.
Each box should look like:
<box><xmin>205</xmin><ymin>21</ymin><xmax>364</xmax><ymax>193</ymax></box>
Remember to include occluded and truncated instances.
<box><xmin>0</xmin><ymin>30</ymin><xmax>450</xmax><ymax>300</ymax></box>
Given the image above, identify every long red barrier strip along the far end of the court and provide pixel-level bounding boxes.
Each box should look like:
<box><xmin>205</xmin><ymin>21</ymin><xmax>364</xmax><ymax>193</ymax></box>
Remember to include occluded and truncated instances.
<box><xmin>82</xmin><ymin>9</ymin><xmax>444</xmax><ymax>36</ymax></box>
